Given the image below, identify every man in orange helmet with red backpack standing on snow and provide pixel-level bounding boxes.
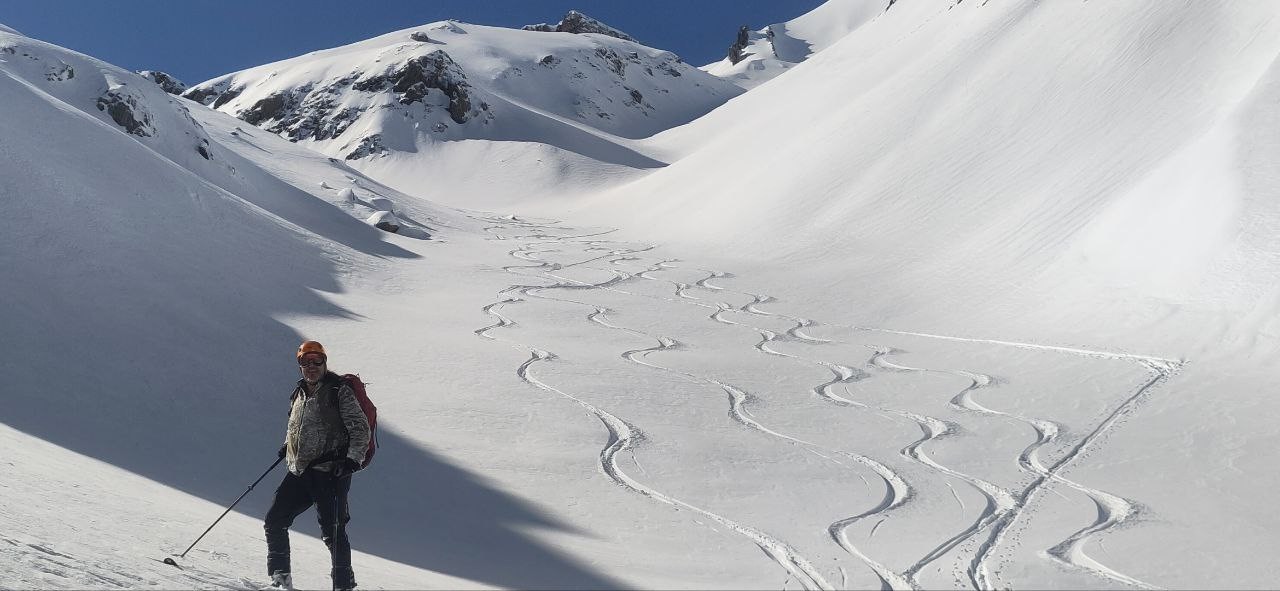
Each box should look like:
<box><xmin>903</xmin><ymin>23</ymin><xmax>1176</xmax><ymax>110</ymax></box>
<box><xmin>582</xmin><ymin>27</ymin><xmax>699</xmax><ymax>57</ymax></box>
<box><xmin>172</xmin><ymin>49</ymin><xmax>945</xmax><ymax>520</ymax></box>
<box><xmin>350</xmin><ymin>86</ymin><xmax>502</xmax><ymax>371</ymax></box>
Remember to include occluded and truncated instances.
<box><xmin>262</xmin><ymin>340</ymin><xmax>370</xmax><ymax>590</ymax></box>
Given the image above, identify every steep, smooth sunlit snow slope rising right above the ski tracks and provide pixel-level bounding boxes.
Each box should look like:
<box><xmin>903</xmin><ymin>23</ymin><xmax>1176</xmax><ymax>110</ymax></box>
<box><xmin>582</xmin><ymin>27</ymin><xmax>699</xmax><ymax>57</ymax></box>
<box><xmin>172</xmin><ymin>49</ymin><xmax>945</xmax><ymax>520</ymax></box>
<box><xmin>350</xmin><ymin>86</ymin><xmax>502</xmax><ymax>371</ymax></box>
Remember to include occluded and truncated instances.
<box><xmin>584</xmin><ymin>3</ymin><xmax>1280</xmax><ymax>356</ymax></box>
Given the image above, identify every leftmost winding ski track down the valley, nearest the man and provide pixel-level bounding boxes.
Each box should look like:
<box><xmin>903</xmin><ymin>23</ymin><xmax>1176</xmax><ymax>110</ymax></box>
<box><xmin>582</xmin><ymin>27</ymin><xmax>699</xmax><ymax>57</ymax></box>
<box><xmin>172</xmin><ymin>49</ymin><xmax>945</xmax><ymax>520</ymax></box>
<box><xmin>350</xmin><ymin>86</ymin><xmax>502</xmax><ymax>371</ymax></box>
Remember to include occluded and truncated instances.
<box><xmin>475</xmin><ymin>220</ymin><xmax>833</xmax><ymax>590</ymax></box>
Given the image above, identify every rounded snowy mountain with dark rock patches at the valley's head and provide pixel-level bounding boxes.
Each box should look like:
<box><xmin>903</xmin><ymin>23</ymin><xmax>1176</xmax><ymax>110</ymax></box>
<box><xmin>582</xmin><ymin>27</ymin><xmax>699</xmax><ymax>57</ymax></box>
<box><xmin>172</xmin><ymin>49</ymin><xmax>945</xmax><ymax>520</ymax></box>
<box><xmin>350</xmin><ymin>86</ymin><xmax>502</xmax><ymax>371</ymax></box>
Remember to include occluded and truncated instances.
<box><xmin>184</xmin><ymin>13</ymin><xmax>741</xmax><ymax>205</ymax></box>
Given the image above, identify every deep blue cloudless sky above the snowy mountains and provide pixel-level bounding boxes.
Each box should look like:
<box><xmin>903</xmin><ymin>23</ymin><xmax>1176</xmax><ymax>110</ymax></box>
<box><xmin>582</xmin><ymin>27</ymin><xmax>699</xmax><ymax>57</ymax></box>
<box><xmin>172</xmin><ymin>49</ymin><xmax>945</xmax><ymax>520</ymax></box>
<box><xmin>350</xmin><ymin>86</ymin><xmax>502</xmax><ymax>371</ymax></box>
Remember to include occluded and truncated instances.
<box><xmin>0</xmin><ymin>0</ymin><xmax>823</xmax><ymax>84</ymax></box>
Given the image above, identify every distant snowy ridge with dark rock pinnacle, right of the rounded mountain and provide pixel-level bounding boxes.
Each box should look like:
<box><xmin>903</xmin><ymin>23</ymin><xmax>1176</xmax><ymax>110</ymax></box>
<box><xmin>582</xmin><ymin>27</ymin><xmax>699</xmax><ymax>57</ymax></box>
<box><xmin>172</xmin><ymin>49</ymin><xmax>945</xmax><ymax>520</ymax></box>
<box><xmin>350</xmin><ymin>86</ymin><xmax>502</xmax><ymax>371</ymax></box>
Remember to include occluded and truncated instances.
<box><xmin>701</xmin><ymin>0</ymin><xmax>891</xmax><ymax>88</ymax></box>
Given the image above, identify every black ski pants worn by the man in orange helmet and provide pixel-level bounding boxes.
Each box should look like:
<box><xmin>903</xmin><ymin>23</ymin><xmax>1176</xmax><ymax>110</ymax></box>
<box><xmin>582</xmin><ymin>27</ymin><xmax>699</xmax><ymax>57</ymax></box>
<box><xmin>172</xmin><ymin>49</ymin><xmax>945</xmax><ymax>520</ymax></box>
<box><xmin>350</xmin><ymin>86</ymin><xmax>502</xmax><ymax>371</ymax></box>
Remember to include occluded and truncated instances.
<box><xmin>262</xmin><ymin>469</ymin><xmax>356</xmax><ymax>588</ymax></box>
